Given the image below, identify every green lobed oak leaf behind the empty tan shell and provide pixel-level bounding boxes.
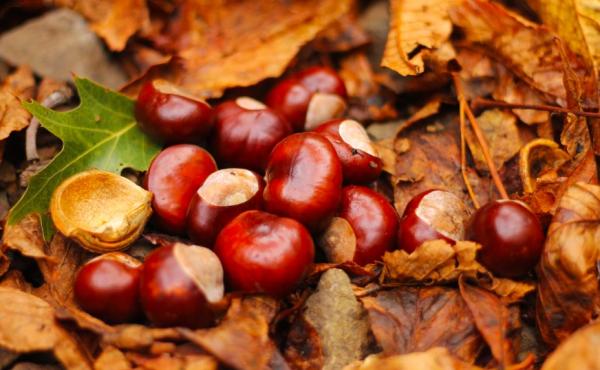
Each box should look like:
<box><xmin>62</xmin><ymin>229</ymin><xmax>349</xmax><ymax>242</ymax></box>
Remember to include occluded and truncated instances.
<box><xmin>7</xmin><ymin>78</ymin><xmax>161</xmax><ymax>240</ymax></box>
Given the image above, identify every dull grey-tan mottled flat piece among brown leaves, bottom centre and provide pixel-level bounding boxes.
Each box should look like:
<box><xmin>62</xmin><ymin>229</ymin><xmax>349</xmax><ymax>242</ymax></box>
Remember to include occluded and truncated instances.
<box><xmin>304</xmin><ymin>269</ymin><xmax>369</xmax><ymax>370</ymax></box>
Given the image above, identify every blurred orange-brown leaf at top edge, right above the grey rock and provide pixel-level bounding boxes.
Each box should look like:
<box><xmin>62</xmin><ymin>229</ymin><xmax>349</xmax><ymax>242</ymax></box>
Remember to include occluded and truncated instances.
<box><xmin>53</xmin><ymin>0</ymin><xmax>150</xmax><ymax>51</ymax></box>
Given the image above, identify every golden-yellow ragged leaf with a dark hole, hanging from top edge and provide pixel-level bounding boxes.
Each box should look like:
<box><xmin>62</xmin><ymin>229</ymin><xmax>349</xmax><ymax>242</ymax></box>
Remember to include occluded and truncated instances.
<box><xmin>381</xmin><ymin>0</ymin><xmax>459</xmax><ymax>76</ymax></box>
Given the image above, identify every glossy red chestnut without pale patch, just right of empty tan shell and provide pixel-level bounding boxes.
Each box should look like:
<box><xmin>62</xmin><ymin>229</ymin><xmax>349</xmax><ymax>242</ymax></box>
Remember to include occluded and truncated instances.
<box><xmin>144</xmin><ymin>144</ymin><xmax>217</xmax><ymax>235</ymax></box>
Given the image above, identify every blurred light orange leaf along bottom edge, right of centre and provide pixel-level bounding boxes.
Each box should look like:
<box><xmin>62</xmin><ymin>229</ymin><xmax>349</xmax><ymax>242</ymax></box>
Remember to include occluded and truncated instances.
<box><xmin>344</xmin><ymin>347</ymin><xmax>483</xmax><ymax>370</ymax></box>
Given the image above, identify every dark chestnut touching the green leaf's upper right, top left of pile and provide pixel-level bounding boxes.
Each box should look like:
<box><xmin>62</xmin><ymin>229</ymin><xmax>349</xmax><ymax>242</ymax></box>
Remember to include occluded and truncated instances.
<box><xmin>135</xmin><ymin>80</ymin><xmax>212</xmax><ymax>144</ymax></box>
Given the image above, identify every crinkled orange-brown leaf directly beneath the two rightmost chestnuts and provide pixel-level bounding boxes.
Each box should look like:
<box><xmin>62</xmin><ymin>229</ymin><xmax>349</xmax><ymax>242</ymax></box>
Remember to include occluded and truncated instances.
<box><xmin>383</xmin><ymin>240</ymin><xmax>535</xmax><ymax>303</ymax></box>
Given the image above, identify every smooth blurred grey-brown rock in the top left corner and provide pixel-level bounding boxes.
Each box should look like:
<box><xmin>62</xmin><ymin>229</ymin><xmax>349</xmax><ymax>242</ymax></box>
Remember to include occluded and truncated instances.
<box><xmin>0</xmin><ymin>9</ymin><xmax>127</xmax><ymax>88</ymax></box>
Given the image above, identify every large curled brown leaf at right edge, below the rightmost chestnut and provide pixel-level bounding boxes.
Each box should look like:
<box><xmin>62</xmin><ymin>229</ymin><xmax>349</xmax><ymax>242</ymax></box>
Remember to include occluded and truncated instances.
<box><xmin>536</xmin><ymin>183</ymin><xmax>600</xmax><ymax>346</ymax></box>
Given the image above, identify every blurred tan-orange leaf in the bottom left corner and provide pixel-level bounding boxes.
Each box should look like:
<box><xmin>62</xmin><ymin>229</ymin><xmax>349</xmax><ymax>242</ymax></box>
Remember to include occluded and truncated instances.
<box><xmin>0</xmin><ymin>287</ymin><xmax>91</xmax><ymax>370</ymax></box>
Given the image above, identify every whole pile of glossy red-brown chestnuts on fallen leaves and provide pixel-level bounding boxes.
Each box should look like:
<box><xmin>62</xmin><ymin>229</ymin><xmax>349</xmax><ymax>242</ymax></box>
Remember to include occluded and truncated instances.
<box><xmin>74</xmin><ymin>67</ymin><xmax>544</xmax><ymax>327</ymax></box>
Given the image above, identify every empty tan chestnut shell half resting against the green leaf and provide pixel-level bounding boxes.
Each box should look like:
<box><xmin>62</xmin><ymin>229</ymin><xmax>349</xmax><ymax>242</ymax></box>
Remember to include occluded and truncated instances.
<box><xmin>50</xmin><ymin>170</ymin><xmax>152</xmax><ymax>253</ymax></box>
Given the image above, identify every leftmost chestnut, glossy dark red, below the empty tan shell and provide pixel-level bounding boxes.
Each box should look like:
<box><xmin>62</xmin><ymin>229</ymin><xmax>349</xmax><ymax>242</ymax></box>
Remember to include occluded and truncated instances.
<box><xmin>73</xmin><ymin>252</ymin><xmax>141</xmax><ymax>324</ymax></box>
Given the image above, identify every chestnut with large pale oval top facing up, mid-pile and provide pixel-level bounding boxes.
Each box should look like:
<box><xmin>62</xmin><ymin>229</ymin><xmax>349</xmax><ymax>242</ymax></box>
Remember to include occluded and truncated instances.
<box><xmin>187</xmin><ymin>168</ymin><xmax>264</xmax><ymax>246</ymax></box>
